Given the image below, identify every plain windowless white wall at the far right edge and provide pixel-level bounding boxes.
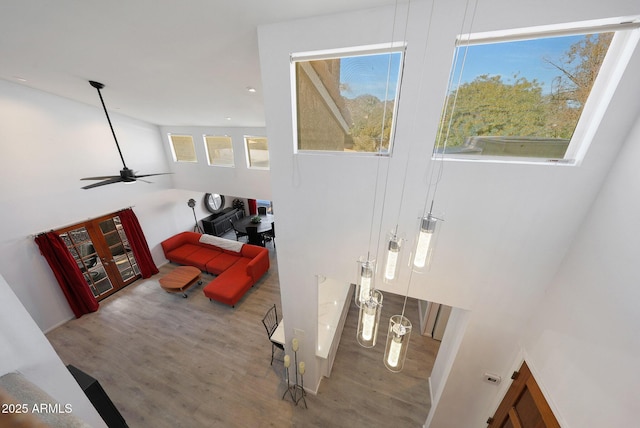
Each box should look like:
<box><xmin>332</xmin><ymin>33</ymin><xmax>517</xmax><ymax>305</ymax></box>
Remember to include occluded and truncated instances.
<box><xmin>523</xmin><ymin>112</ymin><xmax>640</xmax><ymax>427</ymax></box>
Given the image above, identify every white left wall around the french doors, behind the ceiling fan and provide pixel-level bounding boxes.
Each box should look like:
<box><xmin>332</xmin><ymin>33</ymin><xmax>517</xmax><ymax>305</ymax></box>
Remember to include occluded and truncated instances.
<box><xmin>0</xmin><ymin>80</ymin><xmax>210</xmax><ymax>331</ymax></box>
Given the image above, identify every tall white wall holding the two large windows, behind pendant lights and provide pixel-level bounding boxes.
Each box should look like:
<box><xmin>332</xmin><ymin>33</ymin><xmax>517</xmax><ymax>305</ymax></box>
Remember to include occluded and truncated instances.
<box><xmin>259</xmin><ymin>0</ymin><xmax>640</xmax><ymax>427</ymax></box>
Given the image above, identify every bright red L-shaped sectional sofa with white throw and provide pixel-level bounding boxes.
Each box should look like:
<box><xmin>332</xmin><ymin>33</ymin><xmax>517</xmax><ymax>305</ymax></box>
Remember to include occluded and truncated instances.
<box><xmin>161</xmin><ymin>232</ymin><xmax>269</xmax><ymax>307</ymax></box>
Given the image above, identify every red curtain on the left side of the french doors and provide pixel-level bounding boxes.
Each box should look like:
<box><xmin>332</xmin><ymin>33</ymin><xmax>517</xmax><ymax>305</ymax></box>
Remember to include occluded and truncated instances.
<box><xmin>35</xmin><ymin>232</ymin><xmax>99</xmax><ymax>318</ymax></box>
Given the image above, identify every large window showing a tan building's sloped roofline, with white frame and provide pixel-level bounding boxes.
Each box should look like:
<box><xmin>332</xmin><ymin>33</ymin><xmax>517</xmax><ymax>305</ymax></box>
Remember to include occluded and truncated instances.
<box><xmin>291</xmin><ymin>44</ymin><xmax>404</xmax><ymax>154</ymax></box>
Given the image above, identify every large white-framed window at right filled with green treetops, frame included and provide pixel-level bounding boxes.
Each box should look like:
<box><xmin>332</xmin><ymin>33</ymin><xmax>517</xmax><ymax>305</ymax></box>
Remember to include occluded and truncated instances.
<box><xmin>434</xmin><ymin>20</ymin><xmax>638</xmax><ymax>163</ymax></box>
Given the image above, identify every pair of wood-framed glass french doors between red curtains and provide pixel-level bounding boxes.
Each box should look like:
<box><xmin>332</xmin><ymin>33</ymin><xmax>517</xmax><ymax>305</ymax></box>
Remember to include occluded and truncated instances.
<box><xmin>56</xmin><ymin>214</ymin><xmax>141</xmax><ymax>300</ymax></box>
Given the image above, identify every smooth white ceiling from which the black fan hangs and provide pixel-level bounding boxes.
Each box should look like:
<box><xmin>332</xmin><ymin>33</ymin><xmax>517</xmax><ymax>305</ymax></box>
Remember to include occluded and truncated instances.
<box><xmin>0</xmin><ymin>0</ymin><xmax>395</xmax><ymax>126</ymax></box>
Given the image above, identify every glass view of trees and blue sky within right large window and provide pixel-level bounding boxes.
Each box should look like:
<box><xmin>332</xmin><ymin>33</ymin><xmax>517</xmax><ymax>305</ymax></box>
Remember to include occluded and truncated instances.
<box><xmin>435</xmin><ymin>33</ymin><xmax>613</xmax><ymax>158</ymax></box>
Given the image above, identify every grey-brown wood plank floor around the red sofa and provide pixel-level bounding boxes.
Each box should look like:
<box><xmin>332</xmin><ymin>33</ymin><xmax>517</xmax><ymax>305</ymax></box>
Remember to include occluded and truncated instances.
<box><xmin>47</xmin><ymin>246</ymin><xmax>439</xmax><ymax>428</ymax></box>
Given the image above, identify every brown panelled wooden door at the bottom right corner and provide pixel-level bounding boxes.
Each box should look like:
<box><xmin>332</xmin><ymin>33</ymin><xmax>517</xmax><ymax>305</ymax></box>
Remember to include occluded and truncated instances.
<box><xmin>487</xmin><ymin>362</ymin><xmax>560</xmax><ymax>428</ymax></box>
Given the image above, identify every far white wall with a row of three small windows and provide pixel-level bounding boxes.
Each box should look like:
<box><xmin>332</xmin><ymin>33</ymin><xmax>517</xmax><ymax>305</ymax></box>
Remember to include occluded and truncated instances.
<box><xmin>160</xmin><ymin>126</ymin><xmax>277</xmax><ymax>202</ymax></box>
